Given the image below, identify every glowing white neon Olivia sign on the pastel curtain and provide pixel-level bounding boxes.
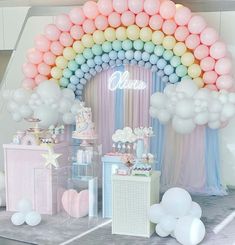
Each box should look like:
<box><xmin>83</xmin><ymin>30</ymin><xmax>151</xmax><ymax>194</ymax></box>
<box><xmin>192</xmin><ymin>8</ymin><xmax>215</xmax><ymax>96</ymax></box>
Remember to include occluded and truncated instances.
<box><xmin>108</xmin><ymin>71</ymin><xmax>147</xmax><ymax>91</ymax></box>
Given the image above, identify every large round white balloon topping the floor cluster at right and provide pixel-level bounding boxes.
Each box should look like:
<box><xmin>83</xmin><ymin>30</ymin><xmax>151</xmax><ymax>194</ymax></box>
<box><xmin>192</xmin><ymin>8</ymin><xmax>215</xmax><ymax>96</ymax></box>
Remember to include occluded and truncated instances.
<box><xmin>161</xmin><ymin>187</ymin><xmax>192</xmax><ymax>218</ymax></box>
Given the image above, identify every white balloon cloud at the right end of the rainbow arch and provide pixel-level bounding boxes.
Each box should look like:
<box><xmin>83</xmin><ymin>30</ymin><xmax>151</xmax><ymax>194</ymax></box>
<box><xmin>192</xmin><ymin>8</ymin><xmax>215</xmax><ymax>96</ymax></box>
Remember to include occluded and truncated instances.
<box><xmin>149</xmin><ymin>80</ymin><xmax>235</xmax><ymax>134</ymax></box>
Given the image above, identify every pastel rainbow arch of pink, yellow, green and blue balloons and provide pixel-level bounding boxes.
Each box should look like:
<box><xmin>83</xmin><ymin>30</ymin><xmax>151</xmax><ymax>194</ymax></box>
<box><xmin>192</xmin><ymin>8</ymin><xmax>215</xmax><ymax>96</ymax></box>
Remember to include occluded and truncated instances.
<box><xmin>5</xmin><ymin>0</ymin><xmax>234</xmax><ymax>133</ymax></box>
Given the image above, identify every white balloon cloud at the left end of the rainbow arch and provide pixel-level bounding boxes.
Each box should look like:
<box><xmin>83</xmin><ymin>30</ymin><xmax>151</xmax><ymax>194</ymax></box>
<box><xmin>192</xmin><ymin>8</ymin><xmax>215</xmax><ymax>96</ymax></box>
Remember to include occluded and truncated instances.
<box><xmin>3</xmin><ymin>81</ymin><xmax>81</xmax><ymax>128</ymax></box>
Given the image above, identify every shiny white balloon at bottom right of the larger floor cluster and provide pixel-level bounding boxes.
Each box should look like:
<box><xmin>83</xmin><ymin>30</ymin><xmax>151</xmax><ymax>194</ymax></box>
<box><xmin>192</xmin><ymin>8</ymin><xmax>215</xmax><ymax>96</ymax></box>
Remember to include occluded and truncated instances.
<box><xmin>175</xmin><ymin>216</ymin><xmax>206</xmax><ymax>245</ymax></box>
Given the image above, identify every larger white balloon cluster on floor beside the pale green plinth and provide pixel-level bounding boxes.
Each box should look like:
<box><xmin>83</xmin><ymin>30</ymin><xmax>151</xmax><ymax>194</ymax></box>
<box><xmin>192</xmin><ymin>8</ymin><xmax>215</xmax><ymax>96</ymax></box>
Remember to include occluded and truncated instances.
<box><xmin>149</xmin><ymin>188</ymin><xmax>205</xmax><ymax>245</ymax></box>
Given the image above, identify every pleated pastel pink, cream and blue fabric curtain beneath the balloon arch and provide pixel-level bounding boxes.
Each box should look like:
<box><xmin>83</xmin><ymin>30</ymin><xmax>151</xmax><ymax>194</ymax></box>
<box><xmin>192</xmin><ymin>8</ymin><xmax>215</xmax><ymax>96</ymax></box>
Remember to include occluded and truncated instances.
<box><xmin>85</xmin><ymin>65</ymin><xmax>226</xmax><ymax>195</ymax></box>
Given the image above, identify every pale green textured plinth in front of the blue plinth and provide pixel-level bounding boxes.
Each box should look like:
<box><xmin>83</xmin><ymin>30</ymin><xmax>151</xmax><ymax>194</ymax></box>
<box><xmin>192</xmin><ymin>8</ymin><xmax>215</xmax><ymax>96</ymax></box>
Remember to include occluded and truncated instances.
<box><xmin>112</xmin><ymin>172</ymin><xmax>160</xmax><ymax>237</ymax></box>
